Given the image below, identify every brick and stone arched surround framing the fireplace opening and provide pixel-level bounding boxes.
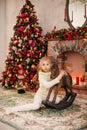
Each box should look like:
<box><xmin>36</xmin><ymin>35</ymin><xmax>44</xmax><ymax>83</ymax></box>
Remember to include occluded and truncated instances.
<box><xmin>47</xmin><ymin>39</ymin><xmax>87</xmax><ymax>91</ymax></box>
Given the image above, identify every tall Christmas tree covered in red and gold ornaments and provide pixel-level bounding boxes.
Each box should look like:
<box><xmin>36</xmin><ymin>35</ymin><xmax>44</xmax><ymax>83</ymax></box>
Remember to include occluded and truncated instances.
<box><xmin>2</xmin><ymin>0</ymin><xmax>45</xmax><ymax>89</ymax></box>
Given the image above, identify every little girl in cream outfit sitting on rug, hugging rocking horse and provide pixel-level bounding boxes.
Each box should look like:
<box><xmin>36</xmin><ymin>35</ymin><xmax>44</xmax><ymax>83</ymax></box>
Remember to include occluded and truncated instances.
<box><xmin>6</xmin><ymin>56</ymin><xmax>65</xmax><ymax>114</ymax></box>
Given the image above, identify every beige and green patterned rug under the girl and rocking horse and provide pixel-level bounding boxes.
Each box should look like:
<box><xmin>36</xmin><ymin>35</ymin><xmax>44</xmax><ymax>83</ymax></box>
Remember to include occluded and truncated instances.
<box><xmin>0</xmin><ymin>88</ymin><xmax>87</xmax><ymax>130</ymax></box>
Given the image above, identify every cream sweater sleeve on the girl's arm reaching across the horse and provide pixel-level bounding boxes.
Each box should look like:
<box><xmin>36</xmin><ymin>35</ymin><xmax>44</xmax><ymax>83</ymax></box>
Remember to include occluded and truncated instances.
<box><xmin>39</xmin><ymin>72</ymin><xmax>60</xmax><ymax>88</ymax></box>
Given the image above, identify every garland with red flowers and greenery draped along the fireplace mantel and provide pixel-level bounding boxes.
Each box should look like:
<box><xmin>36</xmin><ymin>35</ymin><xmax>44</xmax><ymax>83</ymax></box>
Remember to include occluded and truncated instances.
<box><xmin>45</xmin><ymin>27</ymin><xmax>87</xmax><ymax>40</ymax></box>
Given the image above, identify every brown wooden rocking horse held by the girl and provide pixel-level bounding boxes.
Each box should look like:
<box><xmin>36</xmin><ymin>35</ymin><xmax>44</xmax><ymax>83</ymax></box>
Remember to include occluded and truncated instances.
<box><xmin>43</xmin><ymin>54</ymin><xmax>77</xmax><ymax>110</ymax></box>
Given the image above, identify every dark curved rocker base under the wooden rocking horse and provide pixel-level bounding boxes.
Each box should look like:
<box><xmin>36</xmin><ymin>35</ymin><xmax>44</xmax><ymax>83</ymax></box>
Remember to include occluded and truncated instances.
<box><xmin>43</xmin><ymin>93</ymin><xmax>77</xmax><ymax>110</ymax></box>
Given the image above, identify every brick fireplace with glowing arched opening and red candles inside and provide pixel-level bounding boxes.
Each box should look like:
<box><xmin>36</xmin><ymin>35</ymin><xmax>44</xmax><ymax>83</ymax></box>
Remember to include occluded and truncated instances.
<box><xmin>47</xmin><ymin>39</ymin><xmax>87</xmax><ymax>87</ymax></box>
